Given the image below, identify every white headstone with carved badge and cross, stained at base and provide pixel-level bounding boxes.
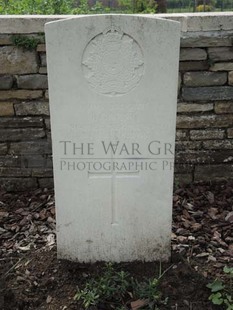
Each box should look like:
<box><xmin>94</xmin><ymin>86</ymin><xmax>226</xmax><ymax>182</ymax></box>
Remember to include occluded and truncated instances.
<box><xmin>46</xmin><ymin>15</ymin><xmax>180</xmax><ymax>262</ymax></box>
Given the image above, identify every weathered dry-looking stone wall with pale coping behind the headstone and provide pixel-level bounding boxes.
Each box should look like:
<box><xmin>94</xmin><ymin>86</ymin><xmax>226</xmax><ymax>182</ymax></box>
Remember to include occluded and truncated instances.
<box><xmin>0</xmin><ymin>13</ymin><xmax>233</xmax><ymax>191</ymax></box>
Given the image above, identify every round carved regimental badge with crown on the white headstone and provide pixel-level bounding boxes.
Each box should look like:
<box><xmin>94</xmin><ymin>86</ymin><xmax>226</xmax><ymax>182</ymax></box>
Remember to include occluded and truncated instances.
<box><xmin>82</xmin><ymin>28</ymin><xmax>144</xmax><ymax>96</ymax></box>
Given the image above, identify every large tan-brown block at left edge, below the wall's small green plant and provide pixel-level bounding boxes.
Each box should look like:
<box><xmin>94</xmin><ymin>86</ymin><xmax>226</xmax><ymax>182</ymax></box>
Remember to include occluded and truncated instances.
<box><xmin>0</xmin><ymin>46</ymin><xmax>38</xmax><ymax>74</ymax></box>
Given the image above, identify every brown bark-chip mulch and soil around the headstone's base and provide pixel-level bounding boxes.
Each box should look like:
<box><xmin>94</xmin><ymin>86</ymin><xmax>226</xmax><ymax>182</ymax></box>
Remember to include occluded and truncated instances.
<box><xmin>0</xmin><ymin>181</ymin><xmax>233</xmax><ymax>310</ymax></box>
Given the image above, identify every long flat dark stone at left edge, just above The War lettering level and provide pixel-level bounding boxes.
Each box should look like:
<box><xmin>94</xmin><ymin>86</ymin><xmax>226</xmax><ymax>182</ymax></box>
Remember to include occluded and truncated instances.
<box><xmin>0</xmin><ymin>128</ymin><xmax>45</xmax><ymax>141</ymax></box>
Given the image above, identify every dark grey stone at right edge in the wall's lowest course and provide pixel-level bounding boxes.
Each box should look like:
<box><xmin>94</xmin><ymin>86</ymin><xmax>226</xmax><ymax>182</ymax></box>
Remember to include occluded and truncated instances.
<box><xmin>194</xmin><ymin>164</ymin><xmax>233</xmax><ymax>181</ymax></box>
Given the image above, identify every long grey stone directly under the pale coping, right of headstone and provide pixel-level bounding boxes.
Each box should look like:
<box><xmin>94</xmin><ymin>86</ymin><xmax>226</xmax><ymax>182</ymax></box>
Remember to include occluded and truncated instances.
<box><xmin>181</xmin><ymin>31</ymin><xmax>233</xmax><ymax>47</ymax></box>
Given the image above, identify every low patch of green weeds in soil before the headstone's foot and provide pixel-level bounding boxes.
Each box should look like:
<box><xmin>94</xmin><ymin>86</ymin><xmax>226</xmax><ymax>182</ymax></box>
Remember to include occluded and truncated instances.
<box><xmin>74</xmin><ymin>264</ymin><xmax>164</xmax><ymax>310</ymax></box>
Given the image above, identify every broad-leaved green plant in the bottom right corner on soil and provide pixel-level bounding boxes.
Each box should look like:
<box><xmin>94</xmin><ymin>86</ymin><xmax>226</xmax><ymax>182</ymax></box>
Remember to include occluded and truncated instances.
<box><xmin>207</xmin><ymin>266</ymin><xmax>233</xmax><ymax>310</ymax></box>
